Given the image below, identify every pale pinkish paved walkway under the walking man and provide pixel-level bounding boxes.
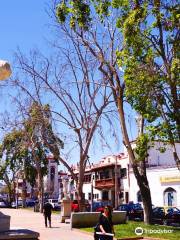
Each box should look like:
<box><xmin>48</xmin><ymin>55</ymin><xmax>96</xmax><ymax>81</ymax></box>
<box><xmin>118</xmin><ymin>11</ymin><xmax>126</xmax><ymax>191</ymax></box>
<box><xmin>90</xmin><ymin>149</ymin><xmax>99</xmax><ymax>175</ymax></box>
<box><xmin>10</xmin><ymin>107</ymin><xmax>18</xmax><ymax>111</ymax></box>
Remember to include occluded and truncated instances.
<box><xmin>0</xmin><ymin>208</ymin><xmax>93</xmax><ymax>240</ymax></box>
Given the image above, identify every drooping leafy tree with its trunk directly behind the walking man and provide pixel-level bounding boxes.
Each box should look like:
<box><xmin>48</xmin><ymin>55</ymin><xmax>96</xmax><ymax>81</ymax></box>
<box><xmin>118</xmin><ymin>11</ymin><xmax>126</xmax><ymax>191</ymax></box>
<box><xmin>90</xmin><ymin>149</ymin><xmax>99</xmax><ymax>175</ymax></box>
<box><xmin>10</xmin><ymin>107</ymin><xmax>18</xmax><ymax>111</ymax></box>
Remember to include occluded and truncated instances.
<box><xmin>24</xmin><ymin>102</ymin><xmax>63</xmax><ymax>212</ymax></box>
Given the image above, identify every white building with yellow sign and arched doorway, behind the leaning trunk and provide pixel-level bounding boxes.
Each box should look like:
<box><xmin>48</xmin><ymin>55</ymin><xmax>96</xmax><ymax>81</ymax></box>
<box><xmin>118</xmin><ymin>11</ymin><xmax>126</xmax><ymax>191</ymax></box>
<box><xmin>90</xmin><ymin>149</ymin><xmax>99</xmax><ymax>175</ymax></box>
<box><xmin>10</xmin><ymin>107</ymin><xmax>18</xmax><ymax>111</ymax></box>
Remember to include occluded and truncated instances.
<box><xmin>129</xmin><ymin>142</ymin><xmax>180</xmax><ymax>207</ymax></box>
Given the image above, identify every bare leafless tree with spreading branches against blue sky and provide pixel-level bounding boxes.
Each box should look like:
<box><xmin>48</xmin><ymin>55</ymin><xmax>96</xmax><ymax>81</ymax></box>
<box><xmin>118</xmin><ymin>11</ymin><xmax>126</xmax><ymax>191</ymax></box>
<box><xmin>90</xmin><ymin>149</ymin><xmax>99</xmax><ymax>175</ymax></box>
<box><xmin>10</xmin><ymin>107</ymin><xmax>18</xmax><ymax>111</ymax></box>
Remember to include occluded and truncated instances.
<box><xmin>14</xmin><ymin>36</ymin><xmax>113</xmax><ymax>210</ymax></box>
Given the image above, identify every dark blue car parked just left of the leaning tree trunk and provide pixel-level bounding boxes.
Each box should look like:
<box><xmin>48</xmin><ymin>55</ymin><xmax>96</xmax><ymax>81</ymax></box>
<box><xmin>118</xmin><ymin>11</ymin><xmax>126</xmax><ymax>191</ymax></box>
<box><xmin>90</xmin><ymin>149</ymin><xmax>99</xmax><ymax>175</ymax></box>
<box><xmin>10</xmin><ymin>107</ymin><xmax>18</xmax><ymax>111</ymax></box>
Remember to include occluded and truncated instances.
<box><xmin>118</xmin><ymin>203</ymin><xmax>144</xmax><ymax>220</ymax></box>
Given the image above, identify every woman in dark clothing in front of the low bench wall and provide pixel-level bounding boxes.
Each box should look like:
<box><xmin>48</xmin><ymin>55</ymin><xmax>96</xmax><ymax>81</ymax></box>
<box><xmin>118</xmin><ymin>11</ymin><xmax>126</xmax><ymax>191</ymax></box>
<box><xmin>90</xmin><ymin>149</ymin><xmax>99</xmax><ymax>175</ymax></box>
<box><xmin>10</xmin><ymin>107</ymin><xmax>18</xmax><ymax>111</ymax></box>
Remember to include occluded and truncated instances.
<box><xmin>99</xmin><ymin>206</ymin><xmax>114</xmax><ymax>240</ymax></box>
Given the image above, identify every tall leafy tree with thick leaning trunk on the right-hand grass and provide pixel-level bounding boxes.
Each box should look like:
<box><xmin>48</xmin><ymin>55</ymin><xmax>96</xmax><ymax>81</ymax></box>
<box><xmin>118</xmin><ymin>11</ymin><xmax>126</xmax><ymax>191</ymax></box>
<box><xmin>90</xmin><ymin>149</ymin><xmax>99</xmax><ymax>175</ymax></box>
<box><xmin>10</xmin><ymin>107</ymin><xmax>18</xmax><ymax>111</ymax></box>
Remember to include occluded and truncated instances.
<box><xmin>56</xmin><ymin>0</ymin><xmax>180</xmax><ymax>223</ymax></box>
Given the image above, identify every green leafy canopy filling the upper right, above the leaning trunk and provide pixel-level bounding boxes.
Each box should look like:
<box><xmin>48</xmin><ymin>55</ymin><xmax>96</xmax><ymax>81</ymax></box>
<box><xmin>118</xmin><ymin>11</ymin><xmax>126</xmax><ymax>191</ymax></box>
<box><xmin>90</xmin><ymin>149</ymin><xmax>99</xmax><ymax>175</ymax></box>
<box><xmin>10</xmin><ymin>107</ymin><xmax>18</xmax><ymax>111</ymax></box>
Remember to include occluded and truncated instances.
<box><xmin>57</xmin><ymin>0</ymin><xmax>180</xmax><ymax>158</ymax></box>
